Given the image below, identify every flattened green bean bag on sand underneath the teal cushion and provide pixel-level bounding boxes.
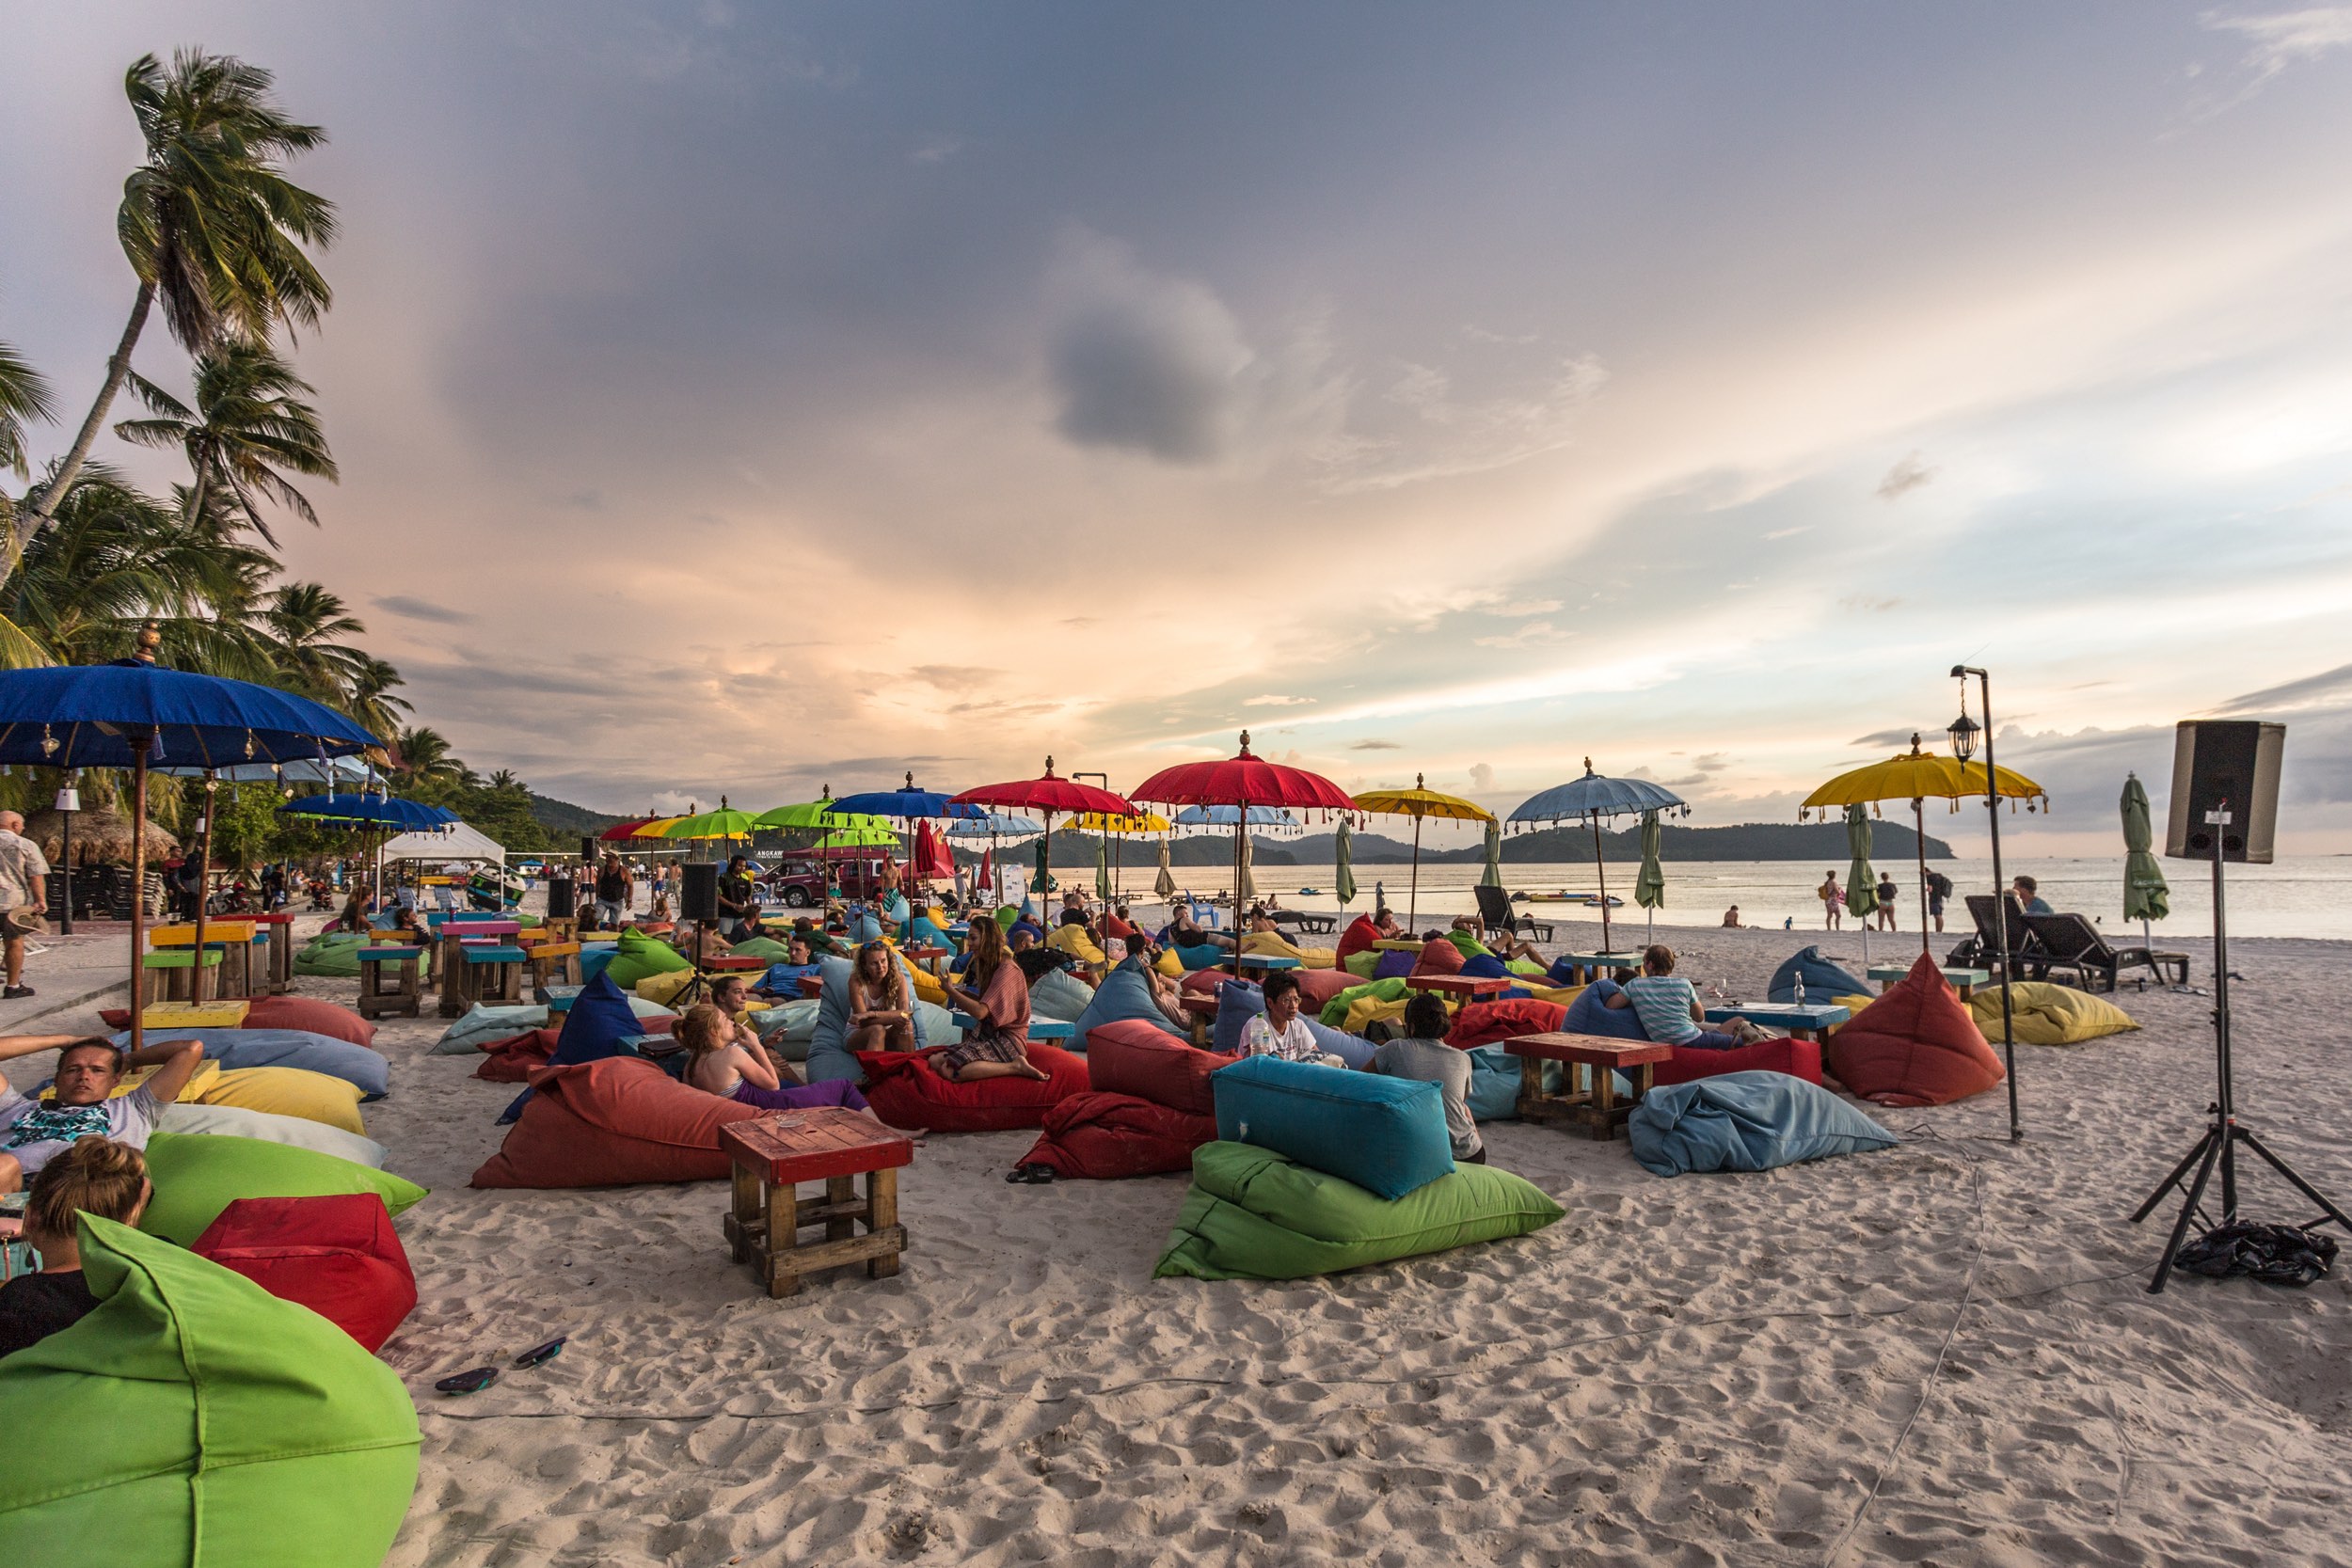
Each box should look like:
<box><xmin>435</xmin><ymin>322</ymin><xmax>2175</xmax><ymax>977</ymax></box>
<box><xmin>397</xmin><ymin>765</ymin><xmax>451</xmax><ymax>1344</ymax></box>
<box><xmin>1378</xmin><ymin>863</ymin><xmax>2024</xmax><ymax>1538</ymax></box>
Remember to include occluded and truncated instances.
<box><xmin>1152</xmin><ymin>1147</ymin><xmax>1562</xmax><ymax>1279</ymax></box>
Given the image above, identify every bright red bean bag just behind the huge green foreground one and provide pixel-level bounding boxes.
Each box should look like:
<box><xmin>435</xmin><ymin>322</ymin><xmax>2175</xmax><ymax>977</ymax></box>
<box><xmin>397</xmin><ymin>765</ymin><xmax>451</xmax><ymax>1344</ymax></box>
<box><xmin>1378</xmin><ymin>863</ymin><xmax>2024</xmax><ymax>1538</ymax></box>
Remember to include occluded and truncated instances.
<box><xmin>193</xmin><ymin>1192</ymin><xmax>417</xmax><ymax>1354</ymax></box>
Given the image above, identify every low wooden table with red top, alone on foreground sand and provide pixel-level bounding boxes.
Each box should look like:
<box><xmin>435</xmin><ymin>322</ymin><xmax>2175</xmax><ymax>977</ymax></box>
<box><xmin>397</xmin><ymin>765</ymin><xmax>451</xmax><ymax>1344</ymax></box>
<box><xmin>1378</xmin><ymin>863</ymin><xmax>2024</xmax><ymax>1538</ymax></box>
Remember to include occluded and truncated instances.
<box><xmin>720</xmin><ymin>1105</ymin><xmax>915</xmax><ymax>1295</ymax></box>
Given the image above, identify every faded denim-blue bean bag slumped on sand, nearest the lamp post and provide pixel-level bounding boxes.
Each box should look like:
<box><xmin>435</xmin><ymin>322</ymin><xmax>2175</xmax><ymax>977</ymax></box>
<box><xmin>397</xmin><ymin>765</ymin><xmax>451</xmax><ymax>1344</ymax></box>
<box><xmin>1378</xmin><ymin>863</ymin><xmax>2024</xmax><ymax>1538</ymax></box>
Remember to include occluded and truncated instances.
<box><xmin>1626</xmin><ymin>1072</ymin><xmax>1900</xmax><ymax>1176</ymax></box>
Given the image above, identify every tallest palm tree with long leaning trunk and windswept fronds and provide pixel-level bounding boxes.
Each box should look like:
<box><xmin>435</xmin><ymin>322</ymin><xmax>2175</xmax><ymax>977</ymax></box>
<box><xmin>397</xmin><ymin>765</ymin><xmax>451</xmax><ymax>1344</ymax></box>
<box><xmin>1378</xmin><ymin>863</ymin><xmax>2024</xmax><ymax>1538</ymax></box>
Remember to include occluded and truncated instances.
<box><xmin>17</xmin><ymin>49</ymin><xmax>334</xmax><ymax>547</ymax></box>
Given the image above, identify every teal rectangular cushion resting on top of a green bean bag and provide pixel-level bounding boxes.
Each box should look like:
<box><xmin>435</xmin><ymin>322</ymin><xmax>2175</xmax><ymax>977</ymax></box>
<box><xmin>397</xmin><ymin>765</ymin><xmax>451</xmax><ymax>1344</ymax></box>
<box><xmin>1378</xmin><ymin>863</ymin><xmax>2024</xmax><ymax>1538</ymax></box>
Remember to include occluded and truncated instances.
<box><xmin>1212</xmin><ymin>1055</ymin><xmax>1454</xmax><ymax>1199</ymax></box>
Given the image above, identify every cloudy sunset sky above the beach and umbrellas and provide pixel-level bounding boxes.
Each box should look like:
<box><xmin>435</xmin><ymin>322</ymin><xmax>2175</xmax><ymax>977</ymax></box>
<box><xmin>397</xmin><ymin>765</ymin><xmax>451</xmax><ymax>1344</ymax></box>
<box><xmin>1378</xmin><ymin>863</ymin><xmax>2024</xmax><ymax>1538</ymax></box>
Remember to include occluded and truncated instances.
<box><xmin>0</xmin><ymin>0</ymin><xmax>2352</xmax><ymax>853</ymax></box>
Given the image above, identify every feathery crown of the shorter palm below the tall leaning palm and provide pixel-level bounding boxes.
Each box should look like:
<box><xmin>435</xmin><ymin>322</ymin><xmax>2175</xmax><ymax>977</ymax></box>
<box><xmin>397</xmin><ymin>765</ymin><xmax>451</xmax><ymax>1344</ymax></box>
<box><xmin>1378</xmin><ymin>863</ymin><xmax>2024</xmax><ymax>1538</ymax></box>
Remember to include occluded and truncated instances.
<box><xmin>116</xmin><ymin>339</ymin><xmax>342</xmax><ymax>546</ymax></box>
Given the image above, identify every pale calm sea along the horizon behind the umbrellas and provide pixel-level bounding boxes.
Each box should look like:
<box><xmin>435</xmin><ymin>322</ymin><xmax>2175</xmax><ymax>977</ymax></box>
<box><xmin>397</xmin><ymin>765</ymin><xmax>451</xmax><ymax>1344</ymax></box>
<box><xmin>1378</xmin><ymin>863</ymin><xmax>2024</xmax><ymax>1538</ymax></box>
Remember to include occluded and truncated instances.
<box><xmin>1054</xmin><ymin>856</ymin><xmax>2352</xmax><ymax>941</ymax></box>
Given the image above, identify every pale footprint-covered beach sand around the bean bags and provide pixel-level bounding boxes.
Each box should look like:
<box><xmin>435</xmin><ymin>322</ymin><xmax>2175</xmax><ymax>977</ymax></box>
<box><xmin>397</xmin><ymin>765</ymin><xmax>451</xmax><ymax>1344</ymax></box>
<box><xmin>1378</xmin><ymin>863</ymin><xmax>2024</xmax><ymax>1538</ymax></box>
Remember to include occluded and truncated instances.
<box><xmin>19</xmin><ymin>927</ymin><xmax>2352</xmax><ymax>1566</ymax></box>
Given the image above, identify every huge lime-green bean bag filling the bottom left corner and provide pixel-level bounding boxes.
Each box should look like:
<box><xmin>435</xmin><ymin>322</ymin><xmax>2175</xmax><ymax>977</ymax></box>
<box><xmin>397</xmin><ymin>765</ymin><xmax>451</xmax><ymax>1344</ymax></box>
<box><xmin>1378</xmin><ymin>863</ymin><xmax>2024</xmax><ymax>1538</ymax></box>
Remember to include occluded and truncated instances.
<box><xmin>0</xmin><ymin>1222</ymin><xmax>419</xmax><ymax>1568</ymax></box>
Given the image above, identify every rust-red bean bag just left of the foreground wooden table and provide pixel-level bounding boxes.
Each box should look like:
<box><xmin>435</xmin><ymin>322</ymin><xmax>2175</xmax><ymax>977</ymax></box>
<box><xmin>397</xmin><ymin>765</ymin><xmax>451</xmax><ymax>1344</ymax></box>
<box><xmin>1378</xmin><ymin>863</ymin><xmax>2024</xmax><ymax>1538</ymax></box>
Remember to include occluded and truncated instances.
<box><xmin>473</xmin><ymin>1055</ymin><xmax>760</xmax><ymax>1187</ymax></box>
